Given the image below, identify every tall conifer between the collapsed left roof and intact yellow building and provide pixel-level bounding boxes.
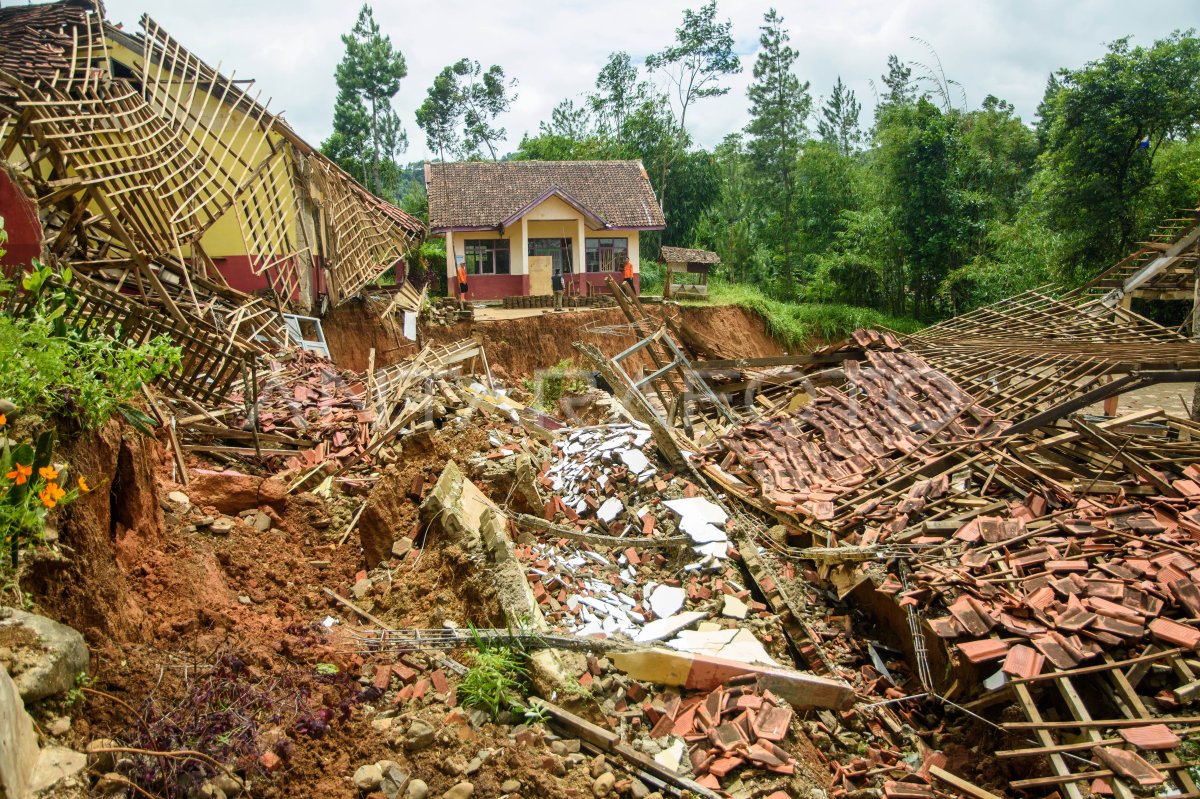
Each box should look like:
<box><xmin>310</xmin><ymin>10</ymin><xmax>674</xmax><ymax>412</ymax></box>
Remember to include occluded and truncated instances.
<box><xmin>323</xmin><ymin>4</ymin><xmax>408</xmax><ymax>194</ymax></box>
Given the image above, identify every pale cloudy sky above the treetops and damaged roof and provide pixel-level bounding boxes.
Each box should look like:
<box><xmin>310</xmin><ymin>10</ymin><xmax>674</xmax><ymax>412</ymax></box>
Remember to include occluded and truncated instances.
<box><xmin>96</xmin><ymin>0</ymin><xmax>1200</xmax><ymax>161</ymax></box>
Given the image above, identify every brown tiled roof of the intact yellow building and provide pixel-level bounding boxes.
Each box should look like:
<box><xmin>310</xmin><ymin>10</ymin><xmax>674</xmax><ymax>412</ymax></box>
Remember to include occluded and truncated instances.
<box><xmin>425</xmin><ymin>161</ymin><xmax>666</xmax><ymax>230</ymax></box>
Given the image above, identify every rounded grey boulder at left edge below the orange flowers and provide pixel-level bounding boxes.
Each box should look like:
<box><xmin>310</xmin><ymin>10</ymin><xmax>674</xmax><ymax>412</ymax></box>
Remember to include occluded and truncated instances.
<box><xmin>0</xmin><ymin>607</ymin><xmax>88</xmax><ymax>703</ymax></box>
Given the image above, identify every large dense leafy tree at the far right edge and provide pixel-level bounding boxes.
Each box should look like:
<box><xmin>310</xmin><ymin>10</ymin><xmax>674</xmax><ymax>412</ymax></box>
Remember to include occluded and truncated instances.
<box><xmin>1040</xmin><ymin>30</ymin><xmax>1200</xmax><ymax>278</ymax></box>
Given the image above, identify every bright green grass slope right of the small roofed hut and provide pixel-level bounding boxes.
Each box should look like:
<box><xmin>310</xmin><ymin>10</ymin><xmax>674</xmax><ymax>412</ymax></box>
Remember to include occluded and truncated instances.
<box><xmin>684</xmin><ymin>281</ymin><xmax>923</xmax><ymax>350</ymax></box>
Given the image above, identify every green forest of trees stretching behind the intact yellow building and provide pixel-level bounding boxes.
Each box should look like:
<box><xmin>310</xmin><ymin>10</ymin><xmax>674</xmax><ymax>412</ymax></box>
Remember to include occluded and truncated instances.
<box><xmin>324</xmin><ymin>1</ymin><xmax>1200</xmax><ymax>322</ymax></box>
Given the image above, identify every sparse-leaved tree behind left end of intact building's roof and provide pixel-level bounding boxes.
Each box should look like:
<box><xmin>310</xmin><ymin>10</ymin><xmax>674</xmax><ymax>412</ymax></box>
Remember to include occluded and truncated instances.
<box><xmin>416</xmin><ymin>59</ymin><xmax>517</xmax><ymax>161</ymax></box>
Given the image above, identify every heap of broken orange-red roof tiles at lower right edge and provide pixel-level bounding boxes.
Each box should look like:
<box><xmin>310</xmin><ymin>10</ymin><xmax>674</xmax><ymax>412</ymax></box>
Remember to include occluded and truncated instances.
<box><xmin>907</xmin><ymin>500</ymin><xmax>1200</xmax><ymax>681</ymax></box>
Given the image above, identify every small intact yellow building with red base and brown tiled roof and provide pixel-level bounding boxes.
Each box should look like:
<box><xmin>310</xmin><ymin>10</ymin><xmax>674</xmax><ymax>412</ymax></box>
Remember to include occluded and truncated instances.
<box><xmin>425</xmin><ymin>161</ymin><xmax>666</xmax><ymax>300</ymax></box>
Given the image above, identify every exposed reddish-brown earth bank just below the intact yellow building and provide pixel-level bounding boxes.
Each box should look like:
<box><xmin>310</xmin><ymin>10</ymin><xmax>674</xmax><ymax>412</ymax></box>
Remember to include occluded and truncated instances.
<box><xmin>323</xmin><ymin>298</ymin><xmax>784</xmax><ymax>378</ymax></box>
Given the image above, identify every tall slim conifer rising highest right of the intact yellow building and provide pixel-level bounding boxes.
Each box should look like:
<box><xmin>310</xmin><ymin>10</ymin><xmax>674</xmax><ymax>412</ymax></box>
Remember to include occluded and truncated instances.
<box><xmin>746</xmin><ymin>8</ymin><xmax>812</xmax><ymax>295</ymax></box>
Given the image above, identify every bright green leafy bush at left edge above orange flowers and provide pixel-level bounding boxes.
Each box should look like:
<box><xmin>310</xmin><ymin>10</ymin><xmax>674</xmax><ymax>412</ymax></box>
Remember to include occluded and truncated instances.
<box><xmin>0</xmin><ymin>263</ymin><xmax>180</xmax><ymax>429</ymax></box>
